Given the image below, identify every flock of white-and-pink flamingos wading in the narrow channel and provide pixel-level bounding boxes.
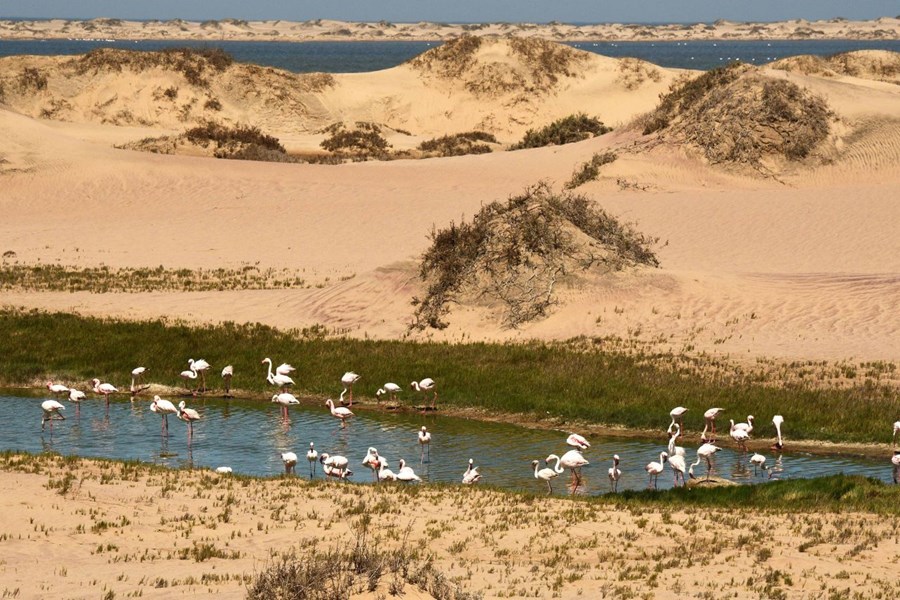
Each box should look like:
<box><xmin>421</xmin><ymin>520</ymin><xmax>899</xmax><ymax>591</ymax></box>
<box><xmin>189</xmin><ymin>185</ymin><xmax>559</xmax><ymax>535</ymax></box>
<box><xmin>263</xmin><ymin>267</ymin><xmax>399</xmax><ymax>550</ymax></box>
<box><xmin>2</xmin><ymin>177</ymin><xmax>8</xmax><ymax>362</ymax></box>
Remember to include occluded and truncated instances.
<box><xmin>33</xmin><ymin>358</ymin><xmax>900</xmax><ymax>494</ymax></box>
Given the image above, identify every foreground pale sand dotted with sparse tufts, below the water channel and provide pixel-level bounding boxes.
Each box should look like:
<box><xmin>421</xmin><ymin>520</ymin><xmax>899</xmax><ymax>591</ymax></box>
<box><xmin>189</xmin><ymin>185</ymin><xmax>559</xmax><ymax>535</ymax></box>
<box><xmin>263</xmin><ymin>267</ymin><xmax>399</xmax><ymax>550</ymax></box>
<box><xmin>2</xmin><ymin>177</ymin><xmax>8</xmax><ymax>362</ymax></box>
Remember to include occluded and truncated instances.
<box><xmin>0</xmin><ymin>457</ymin><xmax>900</xmax><ymax>600</ymax></box>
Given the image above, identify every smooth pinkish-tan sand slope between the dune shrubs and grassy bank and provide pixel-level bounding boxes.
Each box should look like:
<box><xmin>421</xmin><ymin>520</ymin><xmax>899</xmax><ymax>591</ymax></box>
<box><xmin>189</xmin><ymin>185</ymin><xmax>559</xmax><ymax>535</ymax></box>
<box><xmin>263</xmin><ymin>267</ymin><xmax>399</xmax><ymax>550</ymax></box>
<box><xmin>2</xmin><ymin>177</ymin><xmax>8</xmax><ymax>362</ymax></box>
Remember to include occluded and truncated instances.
<box><xmin>0</xmin><ymin>45</ymin><xmax>900</xmax><ymax>361</ymax></box>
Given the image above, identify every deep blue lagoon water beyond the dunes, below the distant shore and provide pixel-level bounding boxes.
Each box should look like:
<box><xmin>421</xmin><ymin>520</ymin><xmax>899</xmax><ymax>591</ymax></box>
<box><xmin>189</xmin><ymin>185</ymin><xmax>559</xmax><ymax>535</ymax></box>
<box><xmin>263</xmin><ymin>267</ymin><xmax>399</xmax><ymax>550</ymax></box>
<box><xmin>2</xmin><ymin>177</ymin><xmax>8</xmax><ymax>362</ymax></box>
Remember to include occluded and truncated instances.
<box><xmin>0</xmin><ymin>40</ymin><xmax>900</xmax><ymax>73</ymax></box>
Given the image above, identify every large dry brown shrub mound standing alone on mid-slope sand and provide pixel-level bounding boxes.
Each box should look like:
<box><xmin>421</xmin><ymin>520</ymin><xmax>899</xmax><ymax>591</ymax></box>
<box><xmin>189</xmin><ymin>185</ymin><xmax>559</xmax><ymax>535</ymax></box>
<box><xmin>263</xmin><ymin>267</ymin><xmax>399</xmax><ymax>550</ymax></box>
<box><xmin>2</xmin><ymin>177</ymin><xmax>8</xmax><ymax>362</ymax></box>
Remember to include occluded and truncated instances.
<box><xmin>412</xmin><ymin>183</ymin><xmax>659</xmax><ymax>329</ymax></box>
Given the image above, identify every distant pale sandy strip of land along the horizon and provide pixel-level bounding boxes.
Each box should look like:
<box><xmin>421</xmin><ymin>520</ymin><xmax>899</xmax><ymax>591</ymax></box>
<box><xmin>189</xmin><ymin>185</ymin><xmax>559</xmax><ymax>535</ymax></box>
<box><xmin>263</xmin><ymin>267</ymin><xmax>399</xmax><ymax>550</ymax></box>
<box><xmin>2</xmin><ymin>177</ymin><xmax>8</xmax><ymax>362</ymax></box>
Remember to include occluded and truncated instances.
<box><xmin>0</xmin><ymin>17</ymin><xmax>900</xmax><ymax>42</ymax></box>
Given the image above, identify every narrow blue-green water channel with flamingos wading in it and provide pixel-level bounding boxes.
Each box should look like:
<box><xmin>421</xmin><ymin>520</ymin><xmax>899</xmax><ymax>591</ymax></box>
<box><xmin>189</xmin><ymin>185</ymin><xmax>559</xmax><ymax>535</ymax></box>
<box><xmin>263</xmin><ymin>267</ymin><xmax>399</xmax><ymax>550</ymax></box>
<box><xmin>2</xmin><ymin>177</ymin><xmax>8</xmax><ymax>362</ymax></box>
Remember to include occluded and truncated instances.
<box><xmin>0</xmin><ymin>394</ymin><xmax>891</xmax><ymax>494</ymax></box>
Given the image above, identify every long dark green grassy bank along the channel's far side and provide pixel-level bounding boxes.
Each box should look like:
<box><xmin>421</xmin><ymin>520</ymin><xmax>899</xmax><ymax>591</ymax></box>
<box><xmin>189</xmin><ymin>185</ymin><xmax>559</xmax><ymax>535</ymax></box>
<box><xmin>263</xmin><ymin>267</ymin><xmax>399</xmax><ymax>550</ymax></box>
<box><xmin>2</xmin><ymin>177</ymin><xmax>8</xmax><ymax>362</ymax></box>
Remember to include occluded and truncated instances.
<box><xmin>0</xmin><ymin>311</ymin><xmax>898</xmax><ymax>442</ymax></box>
